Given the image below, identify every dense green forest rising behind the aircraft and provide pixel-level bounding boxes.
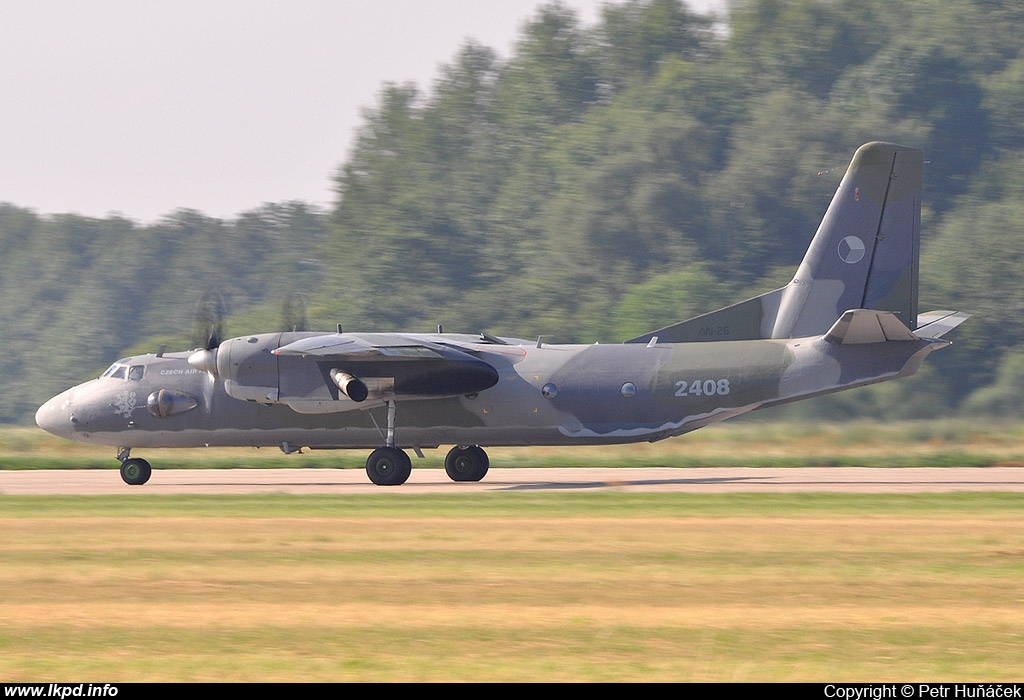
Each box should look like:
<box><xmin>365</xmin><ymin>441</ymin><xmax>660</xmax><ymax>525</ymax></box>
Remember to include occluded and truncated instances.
<box><xmin>0</xmin><ymin>0</ymin><xmax>1024</xmax><ymax>423</ymax></box>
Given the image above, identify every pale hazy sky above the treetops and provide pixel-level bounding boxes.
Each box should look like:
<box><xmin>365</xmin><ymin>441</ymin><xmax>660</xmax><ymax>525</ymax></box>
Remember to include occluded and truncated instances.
<box><xmin>0</xmin><ymin>0</ymin><xmax>724</xmax><ymax>222</ymax></box>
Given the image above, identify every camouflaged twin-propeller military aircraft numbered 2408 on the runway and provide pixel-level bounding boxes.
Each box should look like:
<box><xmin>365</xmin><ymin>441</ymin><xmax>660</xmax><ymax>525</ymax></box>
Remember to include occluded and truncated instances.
<box><xmin>36</xmin><ymin>142</ymin><xmax>968</xmax><ymax>485</ymax></box>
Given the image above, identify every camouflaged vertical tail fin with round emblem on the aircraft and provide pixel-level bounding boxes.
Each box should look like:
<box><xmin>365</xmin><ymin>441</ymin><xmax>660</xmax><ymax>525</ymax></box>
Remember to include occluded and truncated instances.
<box><xmin>627</xmin><ymin>142</ymin><xmax>922</xmax><ymax>343</ymax></box>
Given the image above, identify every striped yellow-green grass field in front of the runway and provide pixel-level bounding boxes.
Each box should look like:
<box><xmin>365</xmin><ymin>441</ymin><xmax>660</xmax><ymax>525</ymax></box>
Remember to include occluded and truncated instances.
<box><xmin>0</xmin><ymin>491</ymin><xmax>1024</xmax><ymax>683</ymax></box>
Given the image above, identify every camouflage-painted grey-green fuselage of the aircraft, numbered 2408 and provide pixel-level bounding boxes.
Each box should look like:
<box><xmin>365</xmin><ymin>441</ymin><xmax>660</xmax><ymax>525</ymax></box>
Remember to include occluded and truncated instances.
<box><xmin>37</xmin><ymin>333</ymin><xmax>948</xmax><ymax>450</ymax></box>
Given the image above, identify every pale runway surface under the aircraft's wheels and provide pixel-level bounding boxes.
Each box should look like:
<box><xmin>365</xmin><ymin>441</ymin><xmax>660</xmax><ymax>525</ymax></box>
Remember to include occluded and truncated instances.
<box><xmin>0</xmin><ymin>467</ymin><xmax>1024</xmax><ymax>495</ymax></box>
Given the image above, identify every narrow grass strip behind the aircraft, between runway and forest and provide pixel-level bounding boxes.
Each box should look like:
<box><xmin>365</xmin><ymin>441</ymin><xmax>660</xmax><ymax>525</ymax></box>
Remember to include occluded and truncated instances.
<box><xmin>6</xmin><ymin>419</ymin><xmax>1024</xmax><ymax>469</ymax></box>
